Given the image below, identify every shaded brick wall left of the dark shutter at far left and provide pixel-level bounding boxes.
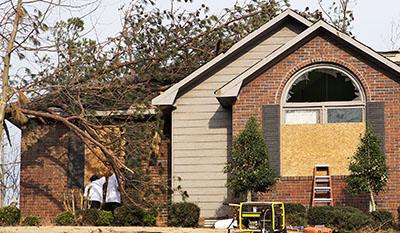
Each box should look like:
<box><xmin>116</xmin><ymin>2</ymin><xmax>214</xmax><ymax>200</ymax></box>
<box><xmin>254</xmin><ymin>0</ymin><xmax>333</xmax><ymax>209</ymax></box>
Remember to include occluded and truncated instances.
<box><xmin>20</xmin><ymin>124</ymin><xmax>69</xmax><ymax>224</ymax></box>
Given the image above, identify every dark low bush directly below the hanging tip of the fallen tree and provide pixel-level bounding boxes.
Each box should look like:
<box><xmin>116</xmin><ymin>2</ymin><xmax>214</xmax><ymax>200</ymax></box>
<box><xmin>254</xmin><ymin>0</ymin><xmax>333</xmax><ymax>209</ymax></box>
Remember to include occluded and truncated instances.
<box><xmin>114</xmin><ymin>206</ymin><xmax>144</xmax><ymax>226</ymax></box>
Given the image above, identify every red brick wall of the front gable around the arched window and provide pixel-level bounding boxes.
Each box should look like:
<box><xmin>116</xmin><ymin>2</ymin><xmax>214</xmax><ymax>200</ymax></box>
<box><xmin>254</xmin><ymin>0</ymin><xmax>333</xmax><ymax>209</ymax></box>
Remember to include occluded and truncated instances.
<box><xmin>232</xmin><ymin>33</ymin><xmax>400</xmax><ymax>212</ymax></box>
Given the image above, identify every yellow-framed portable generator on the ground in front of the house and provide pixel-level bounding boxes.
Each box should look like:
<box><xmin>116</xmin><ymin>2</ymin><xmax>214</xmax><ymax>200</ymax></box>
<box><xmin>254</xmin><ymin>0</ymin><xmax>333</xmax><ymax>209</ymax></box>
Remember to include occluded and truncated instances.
<box><xmin>228</xmin><ymin>202</ymin><xmax>286</xmax><ymax>233</ymax></box>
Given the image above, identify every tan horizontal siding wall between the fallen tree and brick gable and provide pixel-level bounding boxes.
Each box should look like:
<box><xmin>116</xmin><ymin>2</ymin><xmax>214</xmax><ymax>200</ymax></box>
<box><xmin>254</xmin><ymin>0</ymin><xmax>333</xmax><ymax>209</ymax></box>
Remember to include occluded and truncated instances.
<box><xmin>172</xmin><ymin>20</ymin><xmax>306</xmax><ymax>217</ymax></box>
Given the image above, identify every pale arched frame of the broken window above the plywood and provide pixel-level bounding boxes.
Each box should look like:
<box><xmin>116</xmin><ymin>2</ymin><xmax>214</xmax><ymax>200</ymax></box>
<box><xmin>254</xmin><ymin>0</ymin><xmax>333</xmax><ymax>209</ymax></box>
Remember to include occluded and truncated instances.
<box><xmin>281</xmin><ymin>64</ymin><xmax>366</xmax><ymax>125</ymax></box>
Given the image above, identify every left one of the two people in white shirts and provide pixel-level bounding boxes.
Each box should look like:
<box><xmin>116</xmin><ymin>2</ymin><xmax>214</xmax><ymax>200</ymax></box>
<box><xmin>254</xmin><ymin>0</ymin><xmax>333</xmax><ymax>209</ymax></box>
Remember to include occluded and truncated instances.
<box><xmin>83</xmin><ymin>175</ymin><xmax>106</xmax><ymax>209</ymax></box>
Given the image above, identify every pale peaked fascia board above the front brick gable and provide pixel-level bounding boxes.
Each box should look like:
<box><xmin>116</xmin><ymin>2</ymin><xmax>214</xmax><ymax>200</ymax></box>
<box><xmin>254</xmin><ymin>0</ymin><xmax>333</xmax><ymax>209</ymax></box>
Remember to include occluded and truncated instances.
<box><xmin>215</xmin><ymin>20</ymin><xmax>400</xmax><ymax>97</ymax></box>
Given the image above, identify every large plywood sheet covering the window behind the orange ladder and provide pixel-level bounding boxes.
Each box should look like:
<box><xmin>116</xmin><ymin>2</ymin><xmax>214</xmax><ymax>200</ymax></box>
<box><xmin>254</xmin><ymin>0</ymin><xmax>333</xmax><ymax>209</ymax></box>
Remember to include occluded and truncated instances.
<box><xmin>282</xmin><ymin>123</ymin><xmax>365</xmax><ymax>176</ymax></box>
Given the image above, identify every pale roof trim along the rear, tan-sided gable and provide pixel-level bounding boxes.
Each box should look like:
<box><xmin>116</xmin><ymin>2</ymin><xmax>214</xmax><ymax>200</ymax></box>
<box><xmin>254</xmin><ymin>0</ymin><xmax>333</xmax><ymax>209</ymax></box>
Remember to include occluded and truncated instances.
<box><xmin>152</xmin><ymin>9</ymin><xmax>312</xmax><ymax>105</ymax></box>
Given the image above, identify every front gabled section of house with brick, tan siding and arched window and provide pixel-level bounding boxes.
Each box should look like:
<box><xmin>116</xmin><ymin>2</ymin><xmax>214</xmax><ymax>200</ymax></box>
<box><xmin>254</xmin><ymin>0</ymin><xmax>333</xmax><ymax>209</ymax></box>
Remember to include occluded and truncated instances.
<box><xmin>152</xmin><ymin>10</ymin><xmax>400</xmax><ymax>218</ymax></box>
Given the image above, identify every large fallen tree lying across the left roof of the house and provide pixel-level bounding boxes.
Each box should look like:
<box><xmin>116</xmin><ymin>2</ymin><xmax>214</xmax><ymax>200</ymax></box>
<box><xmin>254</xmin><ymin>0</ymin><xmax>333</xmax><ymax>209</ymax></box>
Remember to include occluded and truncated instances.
<box><xmin>3</xmin><ymin>0</ymin><xmax>314</xmax><ymax>208</ymax></box>
